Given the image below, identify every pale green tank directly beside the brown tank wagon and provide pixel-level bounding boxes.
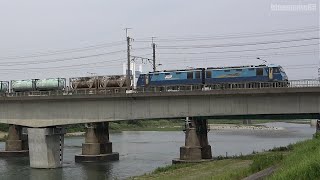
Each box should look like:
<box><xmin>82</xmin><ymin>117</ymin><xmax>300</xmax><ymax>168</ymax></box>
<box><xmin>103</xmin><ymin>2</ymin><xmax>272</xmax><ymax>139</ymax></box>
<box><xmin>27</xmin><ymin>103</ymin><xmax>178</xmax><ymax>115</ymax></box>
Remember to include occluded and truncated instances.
<box><xmin>36</xmin><ymin>78</ymin><xmax>66</xmax><ymax>91</ymax></box>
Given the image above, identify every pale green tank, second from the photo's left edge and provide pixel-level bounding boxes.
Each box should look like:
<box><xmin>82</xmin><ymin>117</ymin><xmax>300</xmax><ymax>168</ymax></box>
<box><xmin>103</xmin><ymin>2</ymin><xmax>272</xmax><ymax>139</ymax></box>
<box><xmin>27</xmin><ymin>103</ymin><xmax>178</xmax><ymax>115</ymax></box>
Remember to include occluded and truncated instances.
<box><xmin>11</xmin><ymin>79</ymin><xmax>38</xmax><ymax>92</ymax></box>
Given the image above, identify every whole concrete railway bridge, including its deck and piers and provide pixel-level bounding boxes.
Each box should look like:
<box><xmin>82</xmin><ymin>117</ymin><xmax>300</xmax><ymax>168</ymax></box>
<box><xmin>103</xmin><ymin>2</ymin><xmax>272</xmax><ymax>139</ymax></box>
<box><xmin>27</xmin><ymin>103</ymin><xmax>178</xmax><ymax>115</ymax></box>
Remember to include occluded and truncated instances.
<box><xmin>0</xmin><ymin>80</ymin><xmax>320</xmax><ymax>168</ymax></box>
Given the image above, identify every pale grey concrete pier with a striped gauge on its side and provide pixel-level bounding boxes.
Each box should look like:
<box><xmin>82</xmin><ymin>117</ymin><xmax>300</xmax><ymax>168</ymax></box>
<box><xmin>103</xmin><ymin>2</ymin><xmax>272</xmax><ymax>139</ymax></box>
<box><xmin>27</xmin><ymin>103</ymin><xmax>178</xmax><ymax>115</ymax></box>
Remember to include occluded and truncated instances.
<box><xmin>28</xmin><ymin>127</ymin><xmax>65</xmax><ymax>169</ymax></box>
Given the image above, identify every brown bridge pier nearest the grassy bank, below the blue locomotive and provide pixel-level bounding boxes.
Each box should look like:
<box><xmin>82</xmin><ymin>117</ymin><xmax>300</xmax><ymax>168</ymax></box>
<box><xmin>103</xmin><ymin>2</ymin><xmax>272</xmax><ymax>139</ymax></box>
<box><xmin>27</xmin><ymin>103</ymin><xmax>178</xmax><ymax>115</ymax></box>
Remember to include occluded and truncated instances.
<box><xmin>172</xmin><ymin>118</ymin><xmax>212</xmax><ymax>164</ymax></box>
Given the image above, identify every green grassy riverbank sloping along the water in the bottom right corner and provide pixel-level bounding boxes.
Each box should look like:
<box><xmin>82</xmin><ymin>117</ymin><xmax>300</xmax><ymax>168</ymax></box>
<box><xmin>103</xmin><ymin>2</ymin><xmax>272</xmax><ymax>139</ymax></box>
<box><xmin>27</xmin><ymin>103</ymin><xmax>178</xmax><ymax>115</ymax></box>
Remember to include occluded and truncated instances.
<box><xmin>132</xmin><ymin>135</ymin><xmax>320</xmax><ymax>180</ymax></box>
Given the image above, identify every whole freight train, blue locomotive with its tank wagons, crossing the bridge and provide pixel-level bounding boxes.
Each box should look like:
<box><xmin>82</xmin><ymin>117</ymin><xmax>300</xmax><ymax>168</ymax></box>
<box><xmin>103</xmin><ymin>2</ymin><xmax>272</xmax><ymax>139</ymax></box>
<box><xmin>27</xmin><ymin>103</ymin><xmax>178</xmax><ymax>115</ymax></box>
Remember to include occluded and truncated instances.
<box><xmin>0</xmin><ymin>65</ymin><xmax>288</xmax><ymax>94</ymax></box>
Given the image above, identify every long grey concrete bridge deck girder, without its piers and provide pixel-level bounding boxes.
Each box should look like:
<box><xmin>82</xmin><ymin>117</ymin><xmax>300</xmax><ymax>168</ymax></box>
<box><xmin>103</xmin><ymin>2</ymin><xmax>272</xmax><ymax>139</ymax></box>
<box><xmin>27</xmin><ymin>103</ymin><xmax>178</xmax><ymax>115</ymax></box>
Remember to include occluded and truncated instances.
<box><xmin>0</xmin><ymin>87</ymin><xmax>320</xmax><ymax>127</ymax></box>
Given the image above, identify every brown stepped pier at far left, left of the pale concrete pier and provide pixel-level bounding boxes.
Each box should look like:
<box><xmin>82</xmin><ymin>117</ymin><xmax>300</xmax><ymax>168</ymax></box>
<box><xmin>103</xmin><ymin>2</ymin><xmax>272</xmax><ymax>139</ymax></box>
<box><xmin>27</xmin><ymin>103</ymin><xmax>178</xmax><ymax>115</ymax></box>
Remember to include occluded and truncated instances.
<box><xmin>0</xmin><ymin>125</ymin><xmax>29</xmax><ymax>157</ymax></box>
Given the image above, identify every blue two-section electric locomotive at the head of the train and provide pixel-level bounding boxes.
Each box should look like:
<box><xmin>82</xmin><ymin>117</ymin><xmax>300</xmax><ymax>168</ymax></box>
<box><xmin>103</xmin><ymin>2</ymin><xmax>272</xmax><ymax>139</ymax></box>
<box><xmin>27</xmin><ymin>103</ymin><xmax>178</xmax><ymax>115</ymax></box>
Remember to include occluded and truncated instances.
<box><xmin>137</xmin><ymin>64</ymin><xmax>288</xmax><ymax>88</ymax></box>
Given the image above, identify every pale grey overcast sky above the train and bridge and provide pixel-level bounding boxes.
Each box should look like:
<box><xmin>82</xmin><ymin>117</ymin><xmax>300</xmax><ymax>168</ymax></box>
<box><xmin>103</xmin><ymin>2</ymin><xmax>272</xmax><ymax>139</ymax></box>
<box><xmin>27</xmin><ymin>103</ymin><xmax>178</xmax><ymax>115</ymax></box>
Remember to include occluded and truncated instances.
<box><xmin>0</xmin><ymin>0</ymin><xmax>319</xmax><ymax>80</ymax></box>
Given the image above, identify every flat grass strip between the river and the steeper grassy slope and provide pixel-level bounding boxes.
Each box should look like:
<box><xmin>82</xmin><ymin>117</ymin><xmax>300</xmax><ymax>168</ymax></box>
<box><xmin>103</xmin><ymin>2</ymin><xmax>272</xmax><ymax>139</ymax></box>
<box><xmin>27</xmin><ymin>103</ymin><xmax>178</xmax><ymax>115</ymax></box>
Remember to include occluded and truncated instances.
<box><xmin>132</xmin><ymin>151</ymin><xmax>286</xmax><ymax>180</ymax></box>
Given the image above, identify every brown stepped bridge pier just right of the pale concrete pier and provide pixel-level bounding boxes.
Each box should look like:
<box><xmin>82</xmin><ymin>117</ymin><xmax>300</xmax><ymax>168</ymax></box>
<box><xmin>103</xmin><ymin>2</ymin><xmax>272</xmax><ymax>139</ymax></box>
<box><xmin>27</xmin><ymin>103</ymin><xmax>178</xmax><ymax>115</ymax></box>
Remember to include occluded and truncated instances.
<box><xmin>75</xmin><ymin>122</ymin><xmax>119</xmax><ymax>162</ymax></box>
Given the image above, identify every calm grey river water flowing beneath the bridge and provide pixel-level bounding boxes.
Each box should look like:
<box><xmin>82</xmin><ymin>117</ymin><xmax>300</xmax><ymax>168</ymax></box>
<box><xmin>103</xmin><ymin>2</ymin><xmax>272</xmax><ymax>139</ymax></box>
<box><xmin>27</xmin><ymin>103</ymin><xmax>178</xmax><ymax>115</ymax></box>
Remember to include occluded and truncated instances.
<box><xmin>0</xmin><ymin>123</ymin><xmax>315</xmax><ymax>180</ymax></box>
